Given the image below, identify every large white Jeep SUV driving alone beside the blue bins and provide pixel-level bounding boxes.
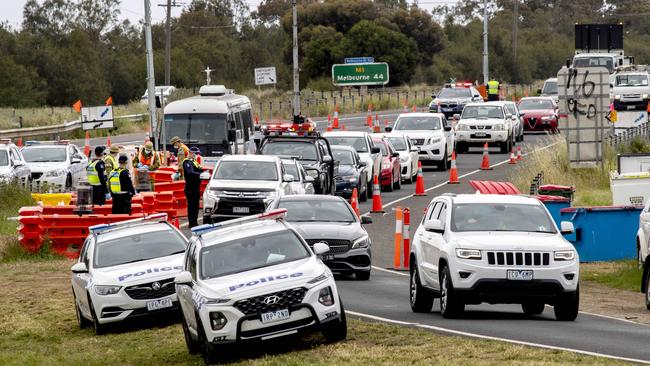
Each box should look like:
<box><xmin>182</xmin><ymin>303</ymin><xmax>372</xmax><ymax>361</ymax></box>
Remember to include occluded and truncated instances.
<box><xmin>409</xmin><ymin>194</ymin><xmax>580</xmax><ymax>320</ymax></box>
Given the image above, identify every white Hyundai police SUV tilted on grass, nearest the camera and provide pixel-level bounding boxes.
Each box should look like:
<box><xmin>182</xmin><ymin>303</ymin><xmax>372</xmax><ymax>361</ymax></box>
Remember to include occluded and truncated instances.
<box><xmin>176</xmin><ymin>209</ymin><xmax>347</xmax><ymax>362</ymax></box>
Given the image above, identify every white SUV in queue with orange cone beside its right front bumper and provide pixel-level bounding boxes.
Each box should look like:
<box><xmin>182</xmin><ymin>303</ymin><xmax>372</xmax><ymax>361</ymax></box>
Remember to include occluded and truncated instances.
<box><xmin>387</xmin><ymin>113</ymin><xmax>455</xmax><ymax>170</ymax></box>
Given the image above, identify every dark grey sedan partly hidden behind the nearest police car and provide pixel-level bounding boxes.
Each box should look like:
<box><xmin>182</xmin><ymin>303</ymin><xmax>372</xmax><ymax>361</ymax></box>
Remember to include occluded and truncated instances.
<box><xmin>268</xmin><ymin>195</ymin><xmax>372</xmax><ymax>280</ymax></box>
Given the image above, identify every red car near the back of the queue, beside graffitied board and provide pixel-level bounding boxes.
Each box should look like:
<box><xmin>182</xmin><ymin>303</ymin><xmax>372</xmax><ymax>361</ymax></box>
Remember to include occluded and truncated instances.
<box><xmin>517</xmin><ymin>97</ymin><xmax>559</xmax><ymax>133</ymax></box>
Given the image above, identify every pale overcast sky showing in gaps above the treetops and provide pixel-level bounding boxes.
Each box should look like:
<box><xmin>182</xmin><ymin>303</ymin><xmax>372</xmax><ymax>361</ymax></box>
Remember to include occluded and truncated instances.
<box><xmin>0</xmin><ymin>0</ymin><xmax>458</xmax><ymax>28</ymax></box>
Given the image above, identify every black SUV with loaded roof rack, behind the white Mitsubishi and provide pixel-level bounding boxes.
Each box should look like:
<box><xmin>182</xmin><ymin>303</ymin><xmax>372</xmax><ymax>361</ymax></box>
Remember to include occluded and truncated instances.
<box><xmin>258</xmin><ymin>135</ymin><xmax>338</xmax><ymax>195</ymax></box>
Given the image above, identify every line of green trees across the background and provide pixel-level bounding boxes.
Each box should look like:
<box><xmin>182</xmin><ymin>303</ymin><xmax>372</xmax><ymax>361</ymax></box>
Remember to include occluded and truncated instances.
<box><xmin>0</xmin><ymin>0</ymin><xmax>650</xmax><ymax>107</ymax></box>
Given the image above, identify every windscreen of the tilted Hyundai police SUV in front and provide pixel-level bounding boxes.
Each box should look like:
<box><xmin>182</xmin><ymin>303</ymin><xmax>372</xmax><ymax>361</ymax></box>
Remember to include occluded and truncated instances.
<box><xmin>199</xmin><ymin>230</ymin><xmax>310</xmax><ymax>280</ymax></box>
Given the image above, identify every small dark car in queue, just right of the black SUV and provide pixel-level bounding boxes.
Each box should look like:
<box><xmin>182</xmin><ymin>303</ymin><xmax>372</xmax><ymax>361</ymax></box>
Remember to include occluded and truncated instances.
<box><xmin>332</xmin><ymin>145</ymin><xmax>368</xmax><ymax>202</ymax></box>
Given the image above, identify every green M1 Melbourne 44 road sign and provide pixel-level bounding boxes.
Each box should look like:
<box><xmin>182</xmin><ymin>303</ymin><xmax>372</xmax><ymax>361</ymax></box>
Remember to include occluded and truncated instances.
<box><xmin>332</xmin><ymin>62</ymin><xmax>388</xmax><ymax>86</ymax></box>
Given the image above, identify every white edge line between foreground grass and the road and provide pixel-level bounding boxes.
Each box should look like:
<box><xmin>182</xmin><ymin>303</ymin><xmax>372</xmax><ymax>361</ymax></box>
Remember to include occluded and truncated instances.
<box><xmin>345</xmin><ymin>310</ymin><xmax>650</xmax><ymax>365</ymax></box>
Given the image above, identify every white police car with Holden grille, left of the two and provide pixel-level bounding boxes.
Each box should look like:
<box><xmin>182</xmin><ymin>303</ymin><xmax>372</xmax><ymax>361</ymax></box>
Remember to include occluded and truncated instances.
<box><xmin>71</xmin><ymin>214</ymin><xmax>187</xmax><ymax>334</ymax></box>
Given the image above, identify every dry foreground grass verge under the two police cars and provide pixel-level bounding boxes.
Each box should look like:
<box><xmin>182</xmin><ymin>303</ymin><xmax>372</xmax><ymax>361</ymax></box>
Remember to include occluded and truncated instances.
<box><xmin>0</xmin><ymin>259</ymin><xmax>623</xmax><ymax>365</ymax></box>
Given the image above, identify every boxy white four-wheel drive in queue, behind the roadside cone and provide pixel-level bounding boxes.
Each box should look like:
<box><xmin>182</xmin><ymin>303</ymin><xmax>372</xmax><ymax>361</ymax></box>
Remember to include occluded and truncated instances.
<box><xmin>456</xmin><ymin>102</ymin><xmax>514</xmax><ymax>154</ymax></box>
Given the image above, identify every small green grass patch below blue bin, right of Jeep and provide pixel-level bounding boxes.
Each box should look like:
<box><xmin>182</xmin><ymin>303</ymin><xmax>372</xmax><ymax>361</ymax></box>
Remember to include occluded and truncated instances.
<box><xmin>580</xmin><ymin>260</ymin><xmax>643</xmax><ymax>292</ymax></box>
